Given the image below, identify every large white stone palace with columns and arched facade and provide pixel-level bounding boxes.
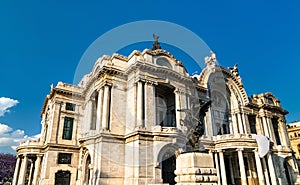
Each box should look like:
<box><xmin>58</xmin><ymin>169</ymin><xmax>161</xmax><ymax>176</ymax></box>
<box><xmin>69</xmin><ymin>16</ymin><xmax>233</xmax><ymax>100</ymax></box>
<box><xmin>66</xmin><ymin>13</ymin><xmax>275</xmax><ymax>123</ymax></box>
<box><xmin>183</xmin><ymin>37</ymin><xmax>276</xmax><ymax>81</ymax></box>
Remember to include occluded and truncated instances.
<box><xmin>13</xmin><ymin>43</ymin><xmax>298</xmax><ymax>185</ymax></box>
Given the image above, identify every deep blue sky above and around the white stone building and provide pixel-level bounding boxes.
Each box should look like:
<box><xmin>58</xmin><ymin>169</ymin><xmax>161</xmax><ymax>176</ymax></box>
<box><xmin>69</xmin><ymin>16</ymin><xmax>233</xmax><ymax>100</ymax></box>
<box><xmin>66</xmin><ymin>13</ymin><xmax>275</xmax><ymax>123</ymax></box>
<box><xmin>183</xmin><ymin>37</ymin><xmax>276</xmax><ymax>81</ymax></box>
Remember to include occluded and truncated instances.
<box><xmin>0</xmin><ymin>0</ymin><xmax>300</xmax><ymax>152</ymax></box>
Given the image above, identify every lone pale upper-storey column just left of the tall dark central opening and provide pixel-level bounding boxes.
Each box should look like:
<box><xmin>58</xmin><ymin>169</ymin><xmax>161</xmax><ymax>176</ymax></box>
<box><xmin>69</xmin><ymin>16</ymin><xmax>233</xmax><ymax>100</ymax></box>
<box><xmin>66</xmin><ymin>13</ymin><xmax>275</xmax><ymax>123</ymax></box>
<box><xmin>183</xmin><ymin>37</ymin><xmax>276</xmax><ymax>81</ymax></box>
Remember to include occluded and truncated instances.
<box><xmin>136</xmin><ymin>81</ymin><xmax>144</xmax><ymax>128</ymax></box>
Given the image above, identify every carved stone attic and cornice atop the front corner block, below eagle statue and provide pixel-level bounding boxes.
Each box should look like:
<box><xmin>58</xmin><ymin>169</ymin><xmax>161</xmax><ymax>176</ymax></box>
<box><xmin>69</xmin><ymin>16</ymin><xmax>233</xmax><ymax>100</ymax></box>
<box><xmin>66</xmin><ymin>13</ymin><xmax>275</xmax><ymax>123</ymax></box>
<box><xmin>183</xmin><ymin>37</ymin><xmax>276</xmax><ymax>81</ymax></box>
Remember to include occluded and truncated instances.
<box><xmin>79</xmin><ymin>49</ymin><xmax>188</xmax><ymax>92</ymax></box>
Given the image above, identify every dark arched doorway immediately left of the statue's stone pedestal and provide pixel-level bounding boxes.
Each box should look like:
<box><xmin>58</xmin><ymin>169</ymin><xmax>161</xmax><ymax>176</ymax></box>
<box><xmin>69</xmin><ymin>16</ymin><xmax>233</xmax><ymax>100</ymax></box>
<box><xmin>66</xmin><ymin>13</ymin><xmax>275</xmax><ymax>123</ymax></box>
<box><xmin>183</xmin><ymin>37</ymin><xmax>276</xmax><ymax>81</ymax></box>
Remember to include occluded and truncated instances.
<box><xmin>162</xmin><ymin>152</ymin><xmax>176</xmax><ymax>185</ymax></box>
